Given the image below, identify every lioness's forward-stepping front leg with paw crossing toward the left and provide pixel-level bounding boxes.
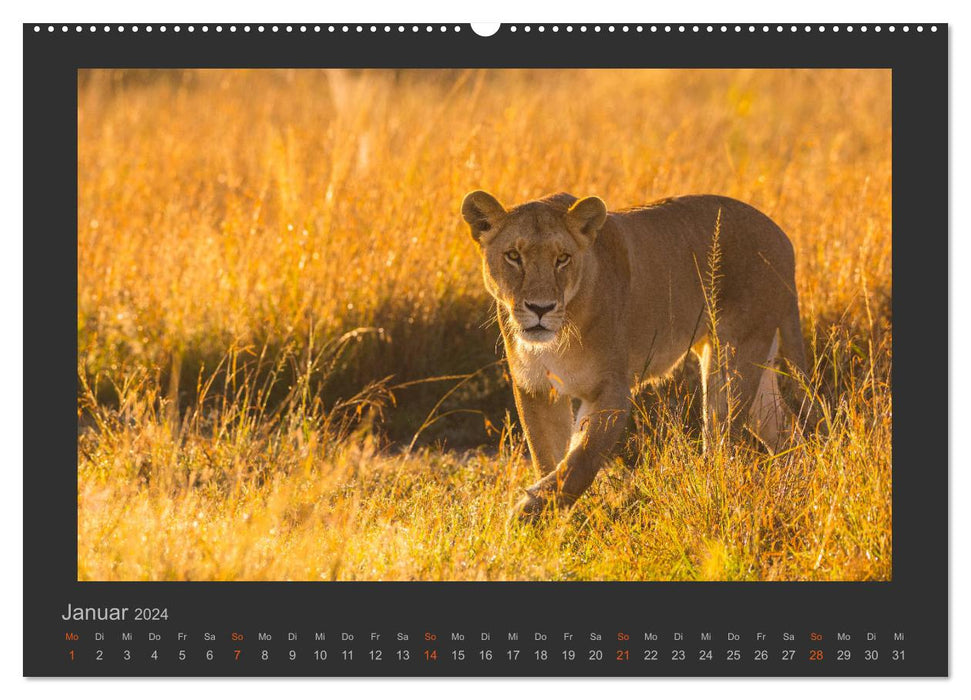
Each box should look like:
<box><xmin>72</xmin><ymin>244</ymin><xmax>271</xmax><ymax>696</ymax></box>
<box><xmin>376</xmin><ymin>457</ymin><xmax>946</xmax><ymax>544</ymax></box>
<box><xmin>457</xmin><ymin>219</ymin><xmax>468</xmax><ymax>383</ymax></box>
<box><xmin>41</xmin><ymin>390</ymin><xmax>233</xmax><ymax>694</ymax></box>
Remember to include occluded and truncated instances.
<box><xmin>515</xmin><ymin>384</ymin><xmax>630</xmax><ymax>519</ymax></box>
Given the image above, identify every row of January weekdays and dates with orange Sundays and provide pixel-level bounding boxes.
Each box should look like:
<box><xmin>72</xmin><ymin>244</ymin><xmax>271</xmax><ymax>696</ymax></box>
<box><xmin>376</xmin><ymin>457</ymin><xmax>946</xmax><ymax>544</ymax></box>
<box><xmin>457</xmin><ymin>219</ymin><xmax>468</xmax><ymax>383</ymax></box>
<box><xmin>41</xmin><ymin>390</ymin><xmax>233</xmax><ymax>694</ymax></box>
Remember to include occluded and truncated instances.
<box><xmin>63</xmin><ymin>629</ymin><xmax>909</xmax><ymax>674</ymax></box>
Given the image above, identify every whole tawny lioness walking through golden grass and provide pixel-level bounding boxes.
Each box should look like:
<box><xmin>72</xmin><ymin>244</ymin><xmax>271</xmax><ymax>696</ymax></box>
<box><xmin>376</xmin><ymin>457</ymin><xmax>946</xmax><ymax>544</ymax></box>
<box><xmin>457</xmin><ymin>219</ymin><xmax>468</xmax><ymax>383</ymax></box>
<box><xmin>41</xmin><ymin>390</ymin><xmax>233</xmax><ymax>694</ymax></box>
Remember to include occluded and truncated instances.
<box><xmin>462</xmin><ymin>191</ymin><xmax>806</xmax><ymax>518</ymax></box>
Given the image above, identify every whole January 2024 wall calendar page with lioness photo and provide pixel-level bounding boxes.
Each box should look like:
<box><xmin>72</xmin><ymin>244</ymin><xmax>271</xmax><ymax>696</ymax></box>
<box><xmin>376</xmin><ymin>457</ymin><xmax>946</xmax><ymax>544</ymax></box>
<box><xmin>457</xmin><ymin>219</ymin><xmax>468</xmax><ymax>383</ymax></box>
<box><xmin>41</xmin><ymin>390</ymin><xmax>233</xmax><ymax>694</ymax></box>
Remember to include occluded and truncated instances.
<box><xmin>24</xmin><ymin>23</ymin><xmax>948</xmax><ymax>676</ymax></box>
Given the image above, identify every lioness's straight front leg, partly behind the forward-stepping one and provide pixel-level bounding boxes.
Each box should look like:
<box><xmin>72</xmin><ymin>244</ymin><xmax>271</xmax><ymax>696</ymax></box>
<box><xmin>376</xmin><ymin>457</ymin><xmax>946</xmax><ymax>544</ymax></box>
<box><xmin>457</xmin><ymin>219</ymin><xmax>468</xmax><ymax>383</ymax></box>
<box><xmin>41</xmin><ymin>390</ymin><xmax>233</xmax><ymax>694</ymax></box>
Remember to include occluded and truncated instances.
<box><xmin>513</xmin><ymin>384</ymin><xmax>573</xmax><ymax>474</ymax></box>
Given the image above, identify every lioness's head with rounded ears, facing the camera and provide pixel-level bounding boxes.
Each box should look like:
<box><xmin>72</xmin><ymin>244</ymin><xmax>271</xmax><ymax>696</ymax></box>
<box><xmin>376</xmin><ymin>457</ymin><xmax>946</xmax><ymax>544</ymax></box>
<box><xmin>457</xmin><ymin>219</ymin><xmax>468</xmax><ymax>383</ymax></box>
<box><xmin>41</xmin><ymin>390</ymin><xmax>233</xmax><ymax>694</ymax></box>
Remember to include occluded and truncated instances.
<box><xmin>462</xmin><ymin>190</ymin><xmax>607</xmax><ymax>349</ymax></box>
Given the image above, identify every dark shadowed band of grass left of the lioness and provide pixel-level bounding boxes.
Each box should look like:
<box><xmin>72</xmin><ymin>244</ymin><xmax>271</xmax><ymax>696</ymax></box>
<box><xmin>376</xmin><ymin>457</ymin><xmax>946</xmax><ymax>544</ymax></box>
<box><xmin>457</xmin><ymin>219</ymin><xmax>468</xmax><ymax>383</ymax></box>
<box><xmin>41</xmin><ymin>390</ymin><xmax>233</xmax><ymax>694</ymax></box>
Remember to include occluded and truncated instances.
<box><xmin>80</xmin><ymin>296</ymin><xmax>515</xmax><ymax>448</ymax></box>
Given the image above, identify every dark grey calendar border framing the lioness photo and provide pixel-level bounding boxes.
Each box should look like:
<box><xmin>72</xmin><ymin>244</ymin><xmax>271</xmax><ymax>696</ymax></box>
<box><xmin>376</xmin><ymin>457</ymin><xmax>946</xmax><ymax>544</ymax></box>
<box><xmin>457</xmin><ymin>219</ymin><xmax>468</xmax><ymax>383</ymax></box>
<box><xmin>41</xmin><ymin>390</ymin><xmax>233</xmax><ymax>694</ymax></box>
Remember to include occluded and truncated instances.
<box><xmin>24</xmin><ymin>24</ymin><xmax>948</xmax><ymax>676</ymax></box>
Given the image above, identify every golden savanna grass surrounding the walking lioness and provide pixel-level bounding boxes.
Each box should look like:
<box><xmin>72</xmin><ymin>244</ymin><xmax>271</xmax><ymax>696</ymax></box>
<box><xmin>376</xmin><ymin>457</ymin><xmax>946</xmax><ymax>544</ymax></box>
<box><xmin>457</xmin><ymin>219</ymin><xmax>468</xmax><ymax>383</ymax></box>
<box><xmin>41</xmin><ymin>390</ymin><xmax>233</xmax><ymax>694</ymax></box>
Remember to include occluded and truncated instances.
<box><xmin>77</xmin><ymin>70</ymin><xmax>892</xmax><ymax>580</ymax></box>
